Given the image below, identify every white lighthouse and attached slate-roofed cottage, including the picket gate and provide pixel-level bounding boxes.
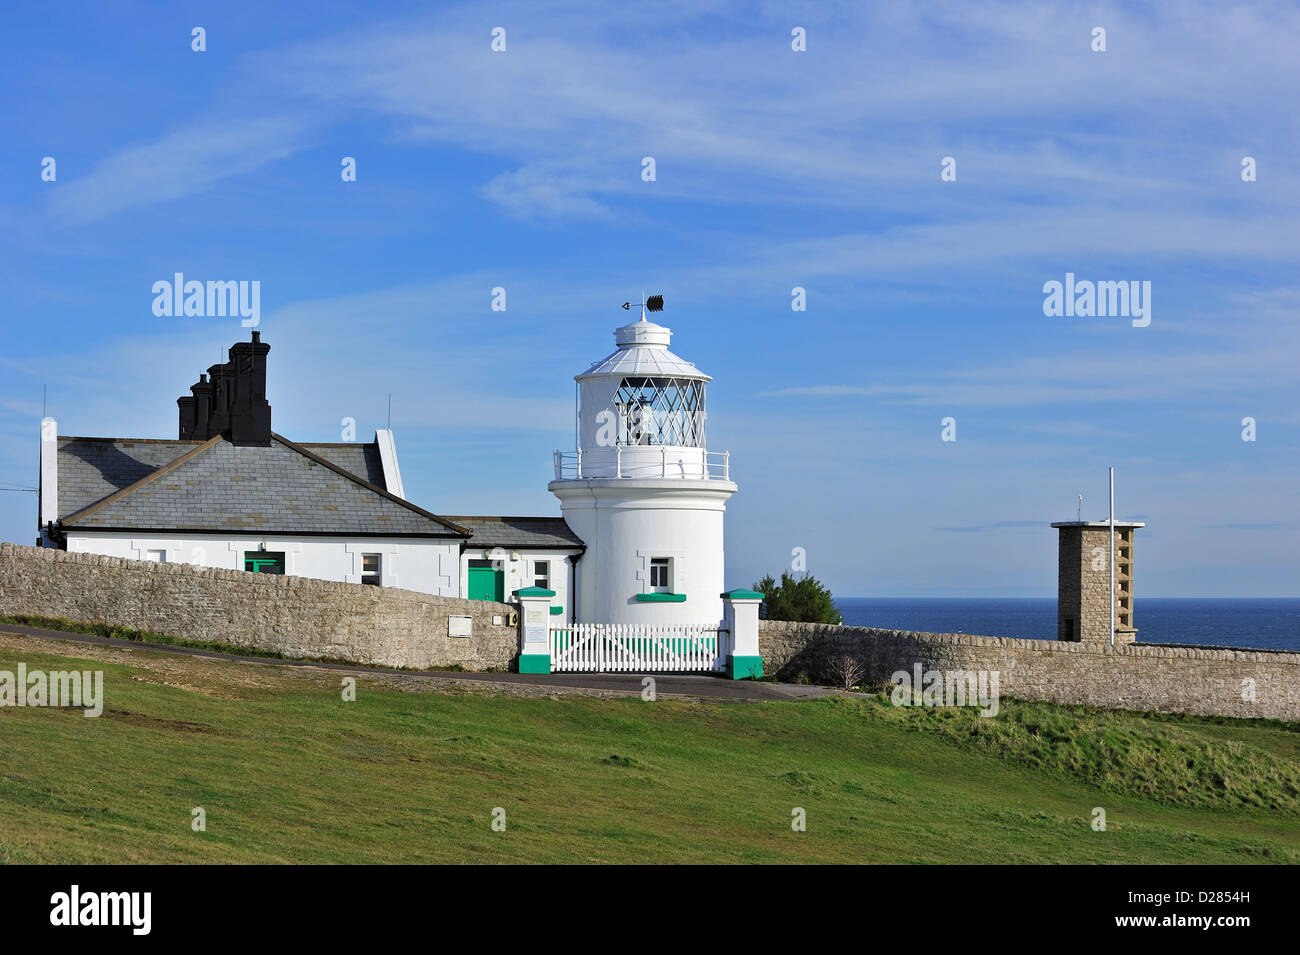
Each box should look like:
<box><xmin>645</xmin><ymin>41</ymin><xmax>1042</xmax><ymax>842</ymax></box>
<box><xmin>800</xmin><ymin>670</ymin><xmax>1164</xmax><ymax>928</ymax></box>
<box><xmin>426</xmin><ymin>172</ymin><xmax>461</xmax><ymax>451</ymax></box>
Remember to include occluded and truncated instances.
<box><xmin>38</xmin><ymin>308</ymin><xmax>762</xmax><ymax>676</ymax></box>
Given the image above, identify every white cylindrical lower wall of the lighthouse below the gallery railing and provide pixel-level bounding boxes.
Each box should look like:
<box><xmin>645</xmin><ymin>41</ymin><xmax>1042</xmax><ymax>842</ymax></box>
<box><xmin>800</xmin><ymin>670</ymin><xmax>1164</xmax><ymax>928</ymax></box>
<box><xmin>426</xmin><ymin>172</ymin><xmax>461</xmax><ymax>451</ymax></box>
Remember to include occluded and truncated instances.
<box><xmin>550</xmin><ymin>478</ymin><xmax>736</xmax><ymax>626</ymax></box>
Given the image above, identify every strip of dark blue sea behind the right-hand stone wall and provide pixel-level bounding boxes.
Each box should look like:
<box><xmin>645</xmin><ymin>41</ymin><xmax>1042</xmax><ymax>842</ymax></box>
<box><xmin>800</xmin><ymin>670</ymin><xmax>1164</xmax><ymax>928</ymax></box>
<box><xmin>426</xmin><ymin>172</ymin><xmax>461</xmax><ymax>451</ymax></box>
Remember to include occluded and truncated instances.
<box><xmin>835</xmin><ymin>596</ymin><xmax>1300</xmax><ymax>651</ymax></box>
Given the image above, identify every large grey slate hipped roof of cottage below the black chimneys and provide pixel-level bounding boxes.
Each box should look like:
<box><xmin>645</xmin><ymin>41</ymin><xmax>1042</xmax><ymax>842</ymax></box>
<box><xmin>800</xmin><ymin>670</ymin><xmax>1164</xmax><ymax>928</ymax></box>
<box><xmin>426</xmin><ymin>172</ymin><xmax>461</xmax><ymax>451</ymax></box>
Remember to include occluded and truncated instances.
<box><xmin>59</xmin><ymin>434</ymin><xmax>465</xmax><ymax>538</ymax></box>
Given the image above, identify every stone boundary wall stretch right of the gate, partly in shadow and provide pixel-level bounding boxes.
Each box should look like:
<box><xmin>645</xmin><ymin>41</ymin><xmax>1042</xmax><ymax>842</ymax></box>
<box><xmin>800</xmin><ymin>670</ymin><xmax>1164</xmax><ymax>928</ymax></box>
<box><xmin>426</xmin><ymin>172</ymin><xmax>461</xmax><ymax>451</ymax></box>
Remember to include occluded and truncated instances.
<box><xmin>758</xmin><ymin>620</ymin><xmax>1300</xmax><ymax>720</ymax></box>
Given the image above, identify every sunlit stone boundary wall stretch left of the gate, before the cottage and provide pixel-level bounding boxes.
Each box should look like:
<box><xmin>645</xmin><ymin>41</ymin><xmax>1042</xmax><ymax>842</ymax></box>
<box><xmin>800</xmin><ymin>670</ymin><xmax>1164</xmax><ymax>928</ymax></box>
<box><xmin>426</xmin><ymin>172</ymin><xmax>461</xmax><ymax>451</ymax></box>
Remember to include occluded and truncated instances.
<box><xmin>0</xmin><ymin>543</ymin><xmax>519</xmax><ymax>670</ymax></box>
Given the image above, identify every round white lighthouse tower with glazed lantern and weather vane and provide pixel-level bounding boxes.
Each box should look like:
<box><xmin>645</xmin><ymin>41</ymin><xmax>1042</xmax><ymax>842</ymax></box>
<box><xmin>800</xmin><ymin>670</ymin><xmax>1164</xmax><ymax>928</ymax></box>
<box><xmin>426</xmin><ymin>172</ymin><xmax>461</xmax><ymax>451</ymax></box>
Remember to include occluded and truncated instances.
<box><xmin>549</xmin><ymin>306</ymin><xmax>736</xmax><ymax>625</ymax></box>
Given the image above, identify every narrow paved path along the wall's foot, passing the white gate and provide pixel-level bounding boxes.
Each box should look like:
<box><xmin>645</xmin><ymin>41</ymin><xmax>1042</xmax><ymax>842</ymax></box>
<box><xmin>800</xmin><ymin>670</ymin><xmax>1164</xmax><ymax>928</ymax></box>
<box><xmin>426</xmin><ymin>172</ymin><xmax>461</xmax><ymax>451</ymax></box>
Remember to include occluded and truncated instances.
<box><xmin>0</xmin><ymin>624</ymin><xmax>839</xmax><ymax>702</ymax></box>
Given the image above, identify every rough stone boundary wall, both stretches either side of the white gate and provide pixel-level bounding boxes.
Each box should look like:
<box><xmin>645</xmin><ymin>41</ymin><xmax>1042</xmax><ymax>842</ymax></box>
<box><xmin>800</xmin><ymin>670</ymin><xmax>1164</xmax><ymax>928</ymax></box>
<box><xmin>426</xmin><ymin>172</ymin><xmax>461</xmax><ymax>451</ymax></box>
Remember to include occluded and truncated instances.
<box><xmin>0</xmin><ymin>543</ymin><xmax>1300</xmax><ymax>720</ymax></box>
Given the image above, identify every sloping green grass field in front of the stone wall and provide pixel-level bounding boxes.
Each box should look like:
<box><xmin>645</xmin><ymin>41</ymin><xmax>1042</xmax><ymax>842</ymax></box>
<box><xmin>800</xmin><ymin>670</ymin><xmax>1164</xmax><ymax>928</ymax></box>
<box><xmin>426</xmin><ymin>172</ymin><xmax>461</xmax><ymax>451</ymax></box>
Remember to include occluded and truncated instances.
<box><xmin>0</xmin><ymin>635</ymin><xmax>1300</xmax><ymax>863</ymax></box>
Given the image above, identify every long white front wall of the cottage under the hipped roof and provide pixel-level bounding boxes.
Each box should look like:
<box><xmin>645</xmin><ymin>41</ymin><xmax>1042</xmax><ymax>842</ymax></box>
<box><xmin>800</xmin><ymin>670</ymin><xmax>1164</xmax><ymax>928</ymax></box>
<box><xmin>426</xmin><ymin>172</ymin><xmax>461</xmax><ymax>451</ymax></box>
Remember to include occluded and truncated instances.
<box><xmin>68</xmin><ymin>533</ymin><xmax>462</xmax><ymax>596</ymax></box>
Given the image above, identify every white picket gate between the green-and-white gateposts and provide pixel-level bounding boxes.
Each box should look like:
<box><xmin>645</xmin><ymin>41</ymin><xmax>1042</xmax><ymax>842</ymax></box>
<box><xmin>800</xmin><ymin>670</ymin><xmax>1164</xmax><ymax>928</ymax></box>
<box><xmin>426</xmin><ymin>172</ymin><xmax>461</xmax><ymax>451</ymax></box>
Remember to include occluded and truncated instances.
<box><xmin>550</xmin><ymin>624</ymin><xmax>727</xmax><ymax>673</ymax></box>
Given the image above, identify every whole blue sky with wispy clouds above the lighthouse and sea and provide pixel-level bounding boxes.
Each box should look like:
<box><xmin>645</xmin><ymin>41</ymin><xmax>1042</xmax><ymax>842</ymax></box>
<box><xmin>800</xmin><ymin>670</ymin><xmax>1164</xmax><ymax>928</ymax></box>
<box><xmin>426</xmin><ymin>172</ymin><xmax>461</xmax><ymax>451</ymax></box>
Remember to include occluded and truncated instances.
<box><xmin>0</xmin><ymin>0</ymin><xmax>1300</xmax><ymax>597</ymax></box>
